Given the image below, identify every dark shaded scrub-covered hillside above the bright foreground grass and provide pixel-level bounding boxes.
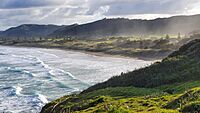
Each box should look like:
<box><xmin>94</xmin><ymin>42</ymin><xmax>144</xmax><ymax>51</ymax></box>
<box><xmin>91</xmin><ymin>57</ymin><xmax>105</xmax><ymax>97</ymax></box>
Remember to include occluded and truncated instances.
<box><xmin>84</xmin><ymin>40</ymin><xmax>200</xmax><ymax>92</ymax></box>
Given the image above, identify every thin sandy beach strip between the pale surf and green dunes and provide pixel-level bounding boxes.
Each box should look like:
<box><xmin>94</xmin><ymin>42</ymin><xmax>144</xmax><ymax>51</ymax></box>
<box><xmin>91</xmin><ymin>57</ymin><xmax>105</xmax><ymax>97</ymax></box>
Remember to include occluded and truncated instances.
<box><xmin>0</xmin><ymin>43</ymin><xmax>165</xmax><ymax>61</ymax></box>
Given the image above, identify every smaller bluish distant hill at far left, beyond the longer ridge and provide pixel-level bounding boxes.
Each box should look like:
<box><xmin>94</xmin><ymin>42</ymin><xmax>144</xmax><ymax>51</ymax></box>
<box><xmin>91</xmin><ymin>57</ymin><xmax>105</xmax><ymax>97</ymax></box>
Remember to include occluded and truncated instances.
<box><xmin>0</xmin><ymin>24</ymin><xmax>64</xmax><ymax>38</ymax></box>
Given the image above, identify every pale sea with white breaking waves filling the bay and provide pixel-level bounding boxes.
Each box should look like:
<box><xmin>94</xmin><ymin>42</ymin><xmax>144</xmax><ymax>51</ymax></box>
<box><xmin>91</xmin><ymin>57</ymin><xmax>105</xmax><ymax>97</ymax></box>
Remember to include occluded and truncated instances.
<box><xmin>0</xmin><ymin>46</ymin><xmax>153</xmax><ymax>113</ymax></box>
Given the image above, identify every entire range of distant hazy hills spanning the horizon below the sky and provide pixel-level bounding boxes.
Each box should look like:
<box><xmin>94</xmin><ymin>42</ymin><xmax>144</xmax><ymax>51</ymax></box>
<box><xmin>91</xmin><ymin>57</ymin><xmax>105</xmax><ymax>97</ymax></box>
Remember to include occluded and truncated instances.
<box><xmin>0</xmin><ymin>15</ymin><xmax>200</xmax><ymax>38</ymax></box>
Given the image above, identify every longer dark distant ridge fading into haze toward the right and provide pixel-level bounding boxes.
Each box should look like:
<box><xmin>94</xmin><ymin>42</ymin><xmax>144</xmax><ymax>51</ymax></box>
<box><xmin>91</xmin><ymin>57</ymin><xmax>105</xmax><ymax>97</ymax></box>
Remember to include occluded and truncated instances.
<box><xmin>50</xmin><ymin>15</ymin><xmax>200</xmax><ymax>38</ymax></box>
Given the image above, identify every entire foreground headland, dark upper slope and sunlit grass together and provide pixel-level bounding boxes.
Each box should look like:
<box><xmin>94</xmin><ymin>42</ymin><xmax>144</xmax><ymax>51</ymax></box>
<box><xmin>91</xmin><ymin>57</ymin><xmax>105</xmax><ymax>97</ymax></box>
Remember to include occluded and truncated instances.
<box><xmin>41</xmin><ymin>40</ymin><xmax>200</xmax><ymax>113</ymax></box>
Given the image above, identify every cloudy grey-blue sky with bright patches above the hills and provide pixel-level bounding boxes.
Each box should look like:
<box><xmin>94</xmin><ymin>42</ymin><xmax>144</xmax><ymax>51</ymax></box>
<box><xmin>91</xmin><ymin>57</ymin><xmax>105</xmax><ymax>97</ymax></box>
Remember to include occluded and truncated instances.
<box><xmin>0</xmin><ymin>0</ymin><xmax>200</xmax><ymax>30</ymax></box>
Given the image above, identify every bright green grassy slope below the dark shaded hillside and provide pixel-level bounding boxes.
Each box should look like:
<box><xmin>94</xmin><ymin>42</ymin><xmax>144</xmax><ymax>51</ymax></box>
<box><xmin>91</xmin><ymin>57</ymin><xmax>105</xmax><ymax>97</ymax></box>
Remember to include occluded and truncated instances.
<box><xmin>42</xmin><ymin>81</ymin><xmax>200</xmax><ymax>113</ymax></box>
